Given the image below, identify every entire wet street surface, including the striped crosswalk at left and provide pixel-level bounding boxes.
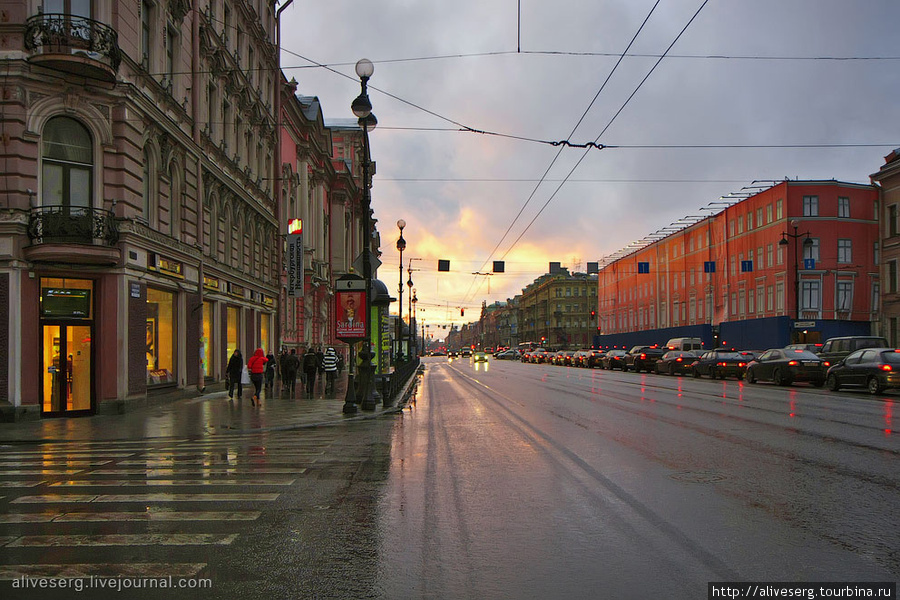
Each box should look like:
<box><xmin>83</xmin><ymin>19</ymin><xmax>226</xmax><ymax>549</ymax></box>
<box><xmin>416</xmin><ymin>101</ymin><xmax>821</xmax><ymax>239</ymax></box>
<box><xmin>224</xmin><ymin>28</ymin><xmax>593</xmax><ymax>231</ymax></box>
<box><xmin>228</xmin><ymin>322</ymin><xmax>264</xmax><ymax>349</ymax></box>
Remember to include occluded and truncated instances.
<box><xmin>0</xmin><ymin>358</ymin><xmax>900</xmax><ymax>600</ymax></box>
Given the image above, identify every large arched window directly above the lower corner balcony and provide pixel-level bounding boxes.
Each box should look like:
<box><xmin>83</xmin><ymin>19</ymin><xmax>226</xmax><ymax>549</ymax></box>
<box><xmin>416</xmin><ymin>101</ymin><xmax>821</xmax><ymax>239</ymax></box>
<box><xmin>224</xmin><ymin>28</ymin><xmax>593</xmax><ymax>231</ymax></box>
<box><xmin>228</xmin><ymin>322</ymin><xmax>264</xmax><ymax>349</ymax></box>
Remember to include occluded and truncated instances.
<box><xmin>41</xmin><ymin>117</ymin><xmax>94</xmax><ymax>209</ymax></box>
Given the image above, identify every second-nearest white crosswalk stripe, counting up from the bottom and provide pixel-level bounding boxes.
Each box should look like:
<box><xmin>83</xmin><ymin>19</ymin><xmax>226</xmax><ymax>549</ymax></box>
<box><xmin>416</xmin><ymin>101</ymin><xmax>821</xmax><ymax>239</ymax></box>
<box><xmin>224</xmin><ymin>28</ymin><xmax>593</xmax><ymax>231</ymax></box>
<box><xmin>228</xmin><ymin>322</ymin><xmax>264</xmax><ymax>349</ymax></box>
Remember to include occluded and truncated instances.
<box><xmin>0</xmin><ymin>533</ymin><xmax>238</xmax><ymax>548</ymax></box>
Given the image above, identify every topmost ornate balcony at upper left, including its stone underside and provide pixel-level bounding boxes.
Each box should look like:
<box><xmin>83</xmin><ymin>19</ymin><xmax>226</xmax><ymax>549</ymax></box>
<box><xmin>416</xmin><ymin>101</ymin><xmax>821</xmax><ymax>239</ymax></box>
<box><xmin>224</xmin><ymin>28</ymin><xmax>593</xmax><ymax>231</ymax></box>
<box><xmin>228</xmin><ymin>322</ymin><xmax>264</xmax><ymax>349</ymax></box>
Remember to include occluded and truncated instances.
<box><xmin>25</xmin><ymin>14</ymin><xmax>122</xmax><ymax>81</ymax></box>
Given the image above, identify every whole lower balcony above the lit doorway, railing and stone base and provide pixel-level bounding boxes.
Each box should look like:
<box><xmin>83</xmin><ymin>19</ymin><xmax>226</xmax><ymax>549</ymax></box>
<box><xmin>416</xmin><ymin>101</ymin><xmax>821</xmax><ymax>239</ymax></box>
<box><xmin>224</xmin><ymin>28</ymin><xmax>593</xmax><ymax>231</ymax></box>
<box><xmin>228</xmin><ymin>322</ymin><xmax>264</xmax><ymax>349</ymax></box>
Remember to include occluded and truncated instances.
<box><xmin>24</xmin><ymin>206</ymin><xmax>120</xmax><ymax>265</ymax></box>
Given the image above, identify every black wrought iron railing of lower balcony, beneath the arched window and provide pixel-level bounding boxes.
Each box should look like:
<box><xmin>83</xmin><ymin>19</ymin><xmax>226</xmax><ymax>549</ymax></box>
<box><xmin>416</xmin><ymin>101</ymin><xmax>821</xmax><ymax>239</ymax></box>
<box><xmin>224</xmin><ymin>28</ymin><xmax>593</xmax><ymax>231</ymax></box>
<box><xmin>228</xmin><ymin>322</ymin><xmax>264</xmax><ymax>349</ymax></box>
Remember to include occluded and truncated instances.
<box><xmin>28</xmin><ymin>206</ymin><xmax>119</xmax><ymax>246</ymax></box>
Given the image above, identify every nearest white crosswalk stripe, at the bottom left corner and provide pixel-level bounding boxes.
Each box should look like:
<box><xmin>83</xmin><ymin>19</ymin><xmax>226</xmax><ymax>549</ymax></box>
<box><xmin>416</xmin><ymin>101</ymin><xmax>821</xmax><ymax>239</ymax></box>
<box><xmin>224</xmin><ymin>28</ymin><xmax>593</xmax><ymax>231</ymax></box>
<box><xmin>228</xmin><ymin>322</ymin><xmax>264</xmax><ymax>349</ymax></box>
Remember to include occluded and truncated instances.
<box><xmin>0</xmin><ymin>563</ymin><xmax>206</xmax><ymax>581</ymax></box>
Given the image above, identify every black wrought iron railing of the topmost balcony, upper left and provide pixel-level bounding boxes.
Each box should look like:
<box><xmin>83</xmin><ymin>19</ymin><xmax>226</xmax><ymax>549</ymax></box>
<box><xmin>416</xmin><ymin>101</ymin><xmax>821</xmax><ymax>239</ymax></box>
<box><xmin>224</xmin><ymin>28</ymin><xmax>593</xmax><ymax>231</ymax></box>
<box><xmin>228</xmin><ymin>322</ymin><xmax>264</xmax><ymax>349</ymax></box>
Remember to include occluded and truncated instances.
<box><xmin>25</xmin><ymin>14</ymin><xmax>122</xmax><ymax>71</ymax></box>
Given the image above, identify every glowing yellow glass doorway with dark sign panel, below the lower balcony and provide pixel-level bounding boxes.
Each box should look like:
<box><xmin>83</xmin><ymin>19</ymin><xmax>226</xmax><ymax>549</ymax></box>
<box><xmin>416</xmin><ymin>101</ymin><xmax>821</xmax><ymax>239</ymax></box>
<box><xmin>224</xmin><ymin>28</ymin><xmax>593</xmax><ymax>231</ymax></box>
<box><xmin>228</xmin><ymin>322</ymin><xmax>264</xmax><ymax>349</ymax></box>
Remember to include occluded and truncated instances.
<box><xmin>40</xmin><ymin>277</ymin><xmax>94</xmax><ymax>416</ymax></box>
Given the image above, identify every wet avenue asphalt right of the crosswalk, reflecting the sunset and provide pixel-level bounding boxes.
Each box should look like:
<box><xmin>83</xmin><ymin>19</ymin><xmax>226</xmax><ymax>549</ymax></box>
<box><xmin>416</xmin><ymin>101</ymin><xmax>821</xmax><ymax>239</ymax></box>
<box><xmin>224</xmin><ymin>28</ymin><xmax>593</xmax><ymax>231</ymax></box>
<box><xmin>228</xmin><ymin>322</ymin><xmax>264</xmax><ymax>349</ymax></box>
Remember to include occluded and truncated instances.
<box><xmin>370</xmin><ymin>359</ymin><xmax>900</xmax><ymax>598</ymax></box>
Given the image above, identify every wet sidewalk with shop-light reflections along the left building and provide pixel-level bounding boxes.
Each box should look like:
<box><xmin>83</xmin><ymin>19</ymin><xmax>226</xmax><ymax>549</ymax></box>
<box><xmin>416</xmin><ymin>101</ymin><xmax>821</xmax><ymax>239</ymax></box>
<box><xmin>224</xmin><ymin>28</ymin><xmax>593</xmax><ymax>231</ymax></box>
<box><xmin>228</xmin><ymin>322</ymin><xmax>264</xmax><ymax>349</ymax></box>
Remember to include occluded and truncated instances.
<box><xmin>0</xmin><ymin>376</ymin><xmax>414</xmax><ymax>445</ymax></box>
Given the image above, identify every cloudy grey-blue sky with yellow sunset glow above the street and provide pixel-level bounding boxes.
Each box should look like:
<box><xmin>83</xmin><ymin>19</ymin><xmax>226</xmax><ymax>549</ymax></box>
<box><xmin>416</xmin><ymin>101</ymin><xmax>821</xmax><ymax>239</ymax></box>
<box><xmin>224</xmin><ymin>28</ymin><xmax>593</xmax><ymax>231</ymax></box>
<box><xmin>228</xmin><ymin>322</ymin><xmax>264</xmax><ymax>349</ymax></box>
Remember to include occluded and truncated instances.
<box><xmin>282</xmin><ymin>0</ymin><xmax>900</xmax><ymax>337</ymax></box>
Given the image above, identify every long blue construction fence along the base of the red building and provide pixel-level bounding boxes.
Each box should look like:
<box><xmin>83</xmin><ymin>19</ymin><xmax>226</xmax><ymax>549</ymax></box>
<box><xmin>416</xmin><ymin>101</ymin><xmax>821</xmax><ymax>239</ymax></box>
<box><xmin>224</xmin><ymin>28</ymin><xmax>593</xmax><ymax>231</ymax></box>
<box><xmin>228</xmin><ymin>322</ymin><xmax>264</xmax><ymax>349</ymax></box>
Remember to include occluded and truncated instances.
<box><xmin>594</xmin><ymin>317</ymin><xmax>871</xmax><ymax>350</ymax></box>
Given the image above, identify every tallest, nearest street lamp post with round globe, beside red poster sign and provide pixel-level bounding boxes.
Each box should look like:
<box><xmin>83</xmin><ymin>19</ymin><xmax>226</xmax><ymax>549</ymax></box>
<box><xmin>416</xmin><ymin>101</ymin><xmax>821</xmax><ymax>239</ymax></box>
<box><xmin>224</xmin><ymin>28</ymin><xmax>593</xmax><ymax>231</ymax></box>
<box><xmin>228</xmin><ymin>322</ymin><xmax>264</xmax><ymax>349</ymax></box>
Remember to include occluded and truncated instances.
<box><xmin>344</xmin><ymin>58</ymin><xmax>378</xmax><ymax>414</ymax></box>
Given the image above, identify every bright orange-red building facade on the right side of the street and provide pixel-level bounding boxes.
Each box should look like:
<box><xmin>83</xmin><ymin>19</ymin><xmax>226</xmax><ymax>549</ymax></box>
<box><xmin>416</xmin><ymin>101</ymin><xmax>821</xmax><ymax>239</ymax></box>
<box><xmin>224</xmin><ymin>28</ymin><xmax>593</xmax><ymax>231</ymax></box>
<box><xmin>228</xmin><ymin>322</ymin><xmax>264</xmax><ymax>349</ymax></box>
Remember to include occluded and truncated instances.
<box><xmin>598</xmin><ymin>181</ymin><xmax>879</xmax><ymax>346</ymax></box>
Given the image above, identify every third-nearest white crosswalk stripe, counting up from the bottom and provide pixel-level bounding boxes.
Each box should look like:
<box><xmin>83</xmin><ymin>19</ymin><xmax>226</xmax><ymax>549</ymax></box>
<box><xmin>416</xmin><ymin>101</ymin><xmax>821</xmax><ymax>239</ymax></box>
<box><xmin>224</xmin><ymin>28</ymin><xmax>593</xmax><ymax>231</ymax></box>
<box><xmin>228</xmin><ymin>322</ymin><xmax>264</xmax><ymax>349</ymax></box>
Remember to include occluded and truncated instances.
<box><xmin>0</xmin><ymin>508</ymin><xmax>262</xmax><ymax>524</ymax></box>
